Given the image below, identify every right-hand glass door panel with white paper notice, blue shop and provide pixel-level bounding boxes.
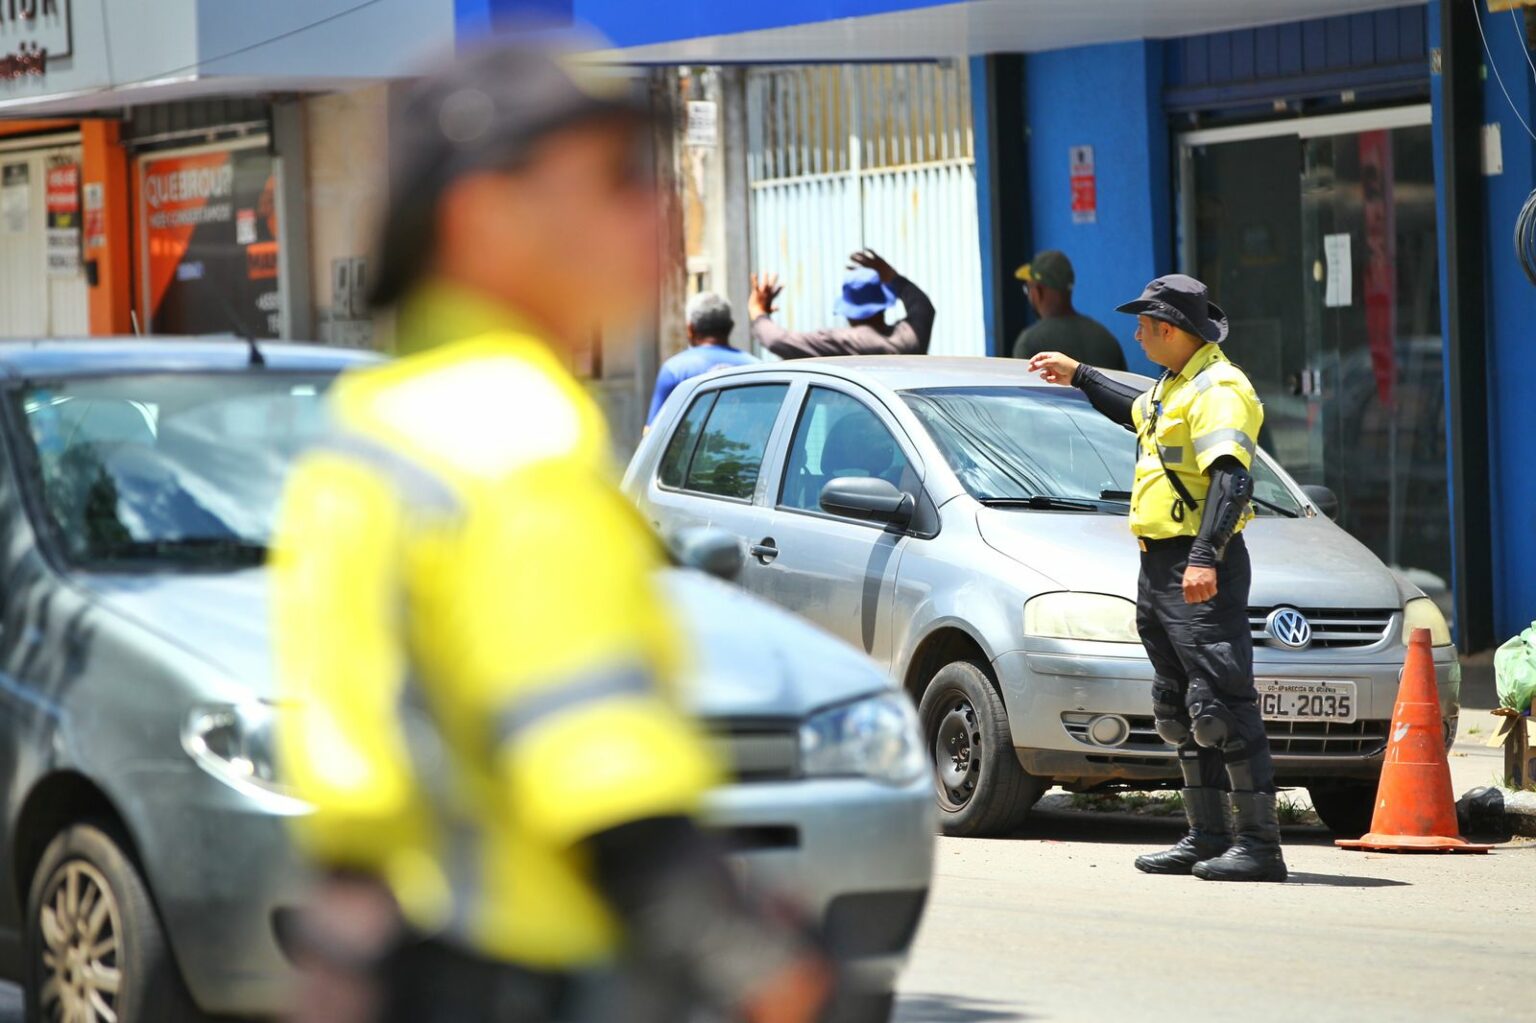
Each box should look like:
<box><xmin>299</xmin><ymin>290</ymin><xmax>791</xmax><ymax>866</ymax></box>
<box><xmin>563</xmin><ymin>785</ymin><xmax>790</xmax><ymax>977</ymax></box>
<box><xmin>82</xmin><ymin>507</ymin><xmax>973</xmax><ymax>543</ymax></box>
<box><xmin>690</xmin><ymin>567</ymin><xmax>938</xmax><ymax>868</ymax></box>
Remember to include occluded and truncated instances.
<box><xmin>1301</xmin><ymin>126</ymin><xmax>1450</xmax><ymax>610</ymax></box>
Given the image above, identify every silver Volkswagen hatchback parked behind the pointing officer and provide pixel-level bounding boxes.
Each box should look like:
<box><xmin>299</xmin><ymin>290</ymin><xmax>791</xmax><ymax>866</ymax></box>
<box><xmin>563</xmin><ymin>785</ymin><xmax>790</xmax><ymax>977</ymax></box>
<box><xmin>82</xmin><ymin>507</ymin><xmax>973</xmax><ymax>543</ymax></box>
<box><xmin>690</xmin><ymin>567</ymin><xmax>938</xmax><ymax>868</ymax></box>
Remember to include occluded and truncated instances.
<box><xmin>625</xmin><ymin>356</ymin><xmax>1461</xmax><ymax>836</ymax></box>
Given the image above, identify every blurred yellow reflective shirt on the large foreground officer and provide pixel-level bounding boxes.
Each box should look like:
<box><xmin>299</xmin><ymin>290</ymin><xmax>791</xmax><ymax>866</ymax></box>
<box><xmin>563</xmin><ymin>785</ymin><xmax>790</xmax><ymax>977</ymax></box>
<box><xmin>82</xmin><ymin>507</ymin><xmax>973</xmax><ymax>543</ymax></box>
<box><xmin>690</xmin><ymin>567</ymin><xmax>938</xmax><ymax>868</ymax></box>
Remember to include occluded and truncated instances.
<box><xmin>272</xmin><ymin>279</ymin><xmax>717</xmax><ymax>969</ymax></box>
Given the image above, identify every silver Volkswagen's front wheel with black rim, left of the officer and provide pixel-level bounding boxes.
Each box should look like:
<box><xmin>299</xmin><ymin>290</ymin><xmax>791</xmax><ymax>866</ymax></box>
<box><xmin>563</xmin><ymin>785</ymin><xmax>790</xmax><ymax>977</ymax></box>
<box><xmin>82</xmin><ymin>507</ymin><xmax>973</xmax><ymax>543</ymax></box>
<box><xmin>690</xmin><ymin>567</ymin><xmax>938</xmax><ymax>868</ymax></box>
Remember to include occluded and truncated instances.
<box><xmin>917</xmin><ymin>660</ymin><xmax>1046</xmax><ymax>837</ymax></box>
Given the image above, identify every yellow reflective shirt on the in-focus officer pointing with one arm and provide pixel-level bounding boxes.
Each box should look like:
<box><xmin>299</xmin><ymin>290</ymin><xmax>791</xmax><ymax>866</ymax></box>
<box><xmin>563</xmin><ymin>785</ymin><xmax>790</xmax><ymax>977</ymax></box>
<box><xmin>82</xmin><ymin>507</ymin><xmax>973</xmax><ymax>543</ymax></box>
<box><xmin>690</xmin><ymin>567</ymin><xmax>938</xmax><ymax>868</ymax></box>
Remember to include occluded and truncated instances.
<box><xmin>1130</xmin><ymin>337</ymin><xmax>1264</xmax><ymax>539</ymax></box>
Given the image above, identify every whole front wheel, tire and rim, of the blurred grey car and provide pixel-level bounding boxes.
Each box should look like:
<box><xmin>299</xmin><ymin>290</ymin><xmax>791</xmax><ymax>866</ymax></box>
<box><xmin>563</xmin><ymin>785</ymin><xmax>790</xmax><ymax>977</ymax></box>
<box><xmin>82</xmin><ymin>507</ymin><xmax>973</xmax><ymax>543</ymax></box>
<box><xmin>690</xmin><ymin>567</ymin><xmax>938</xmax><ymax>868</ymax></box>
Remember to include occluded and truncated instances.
<box><xmin>25</xmin><ymin>823</ymin><xmax>207</xmax><ymax>1023</ymax></box>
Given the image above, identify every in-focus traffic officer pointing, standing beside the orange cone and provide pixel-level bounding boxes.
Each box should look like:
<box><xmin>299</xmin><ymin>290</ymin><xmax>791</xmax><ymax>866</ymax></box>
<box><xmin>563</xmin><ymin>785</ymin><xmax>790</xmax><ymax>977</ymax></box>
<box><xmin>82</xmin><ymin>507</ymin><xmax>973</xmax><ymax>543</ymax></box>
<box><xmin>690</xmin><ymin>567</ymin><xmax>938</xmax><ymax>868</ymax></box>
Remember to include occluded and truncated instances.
<box><xmin>1029</xmin><ymin>273</ymin><xmax>1286</xmax><ymax>882</ymax></box>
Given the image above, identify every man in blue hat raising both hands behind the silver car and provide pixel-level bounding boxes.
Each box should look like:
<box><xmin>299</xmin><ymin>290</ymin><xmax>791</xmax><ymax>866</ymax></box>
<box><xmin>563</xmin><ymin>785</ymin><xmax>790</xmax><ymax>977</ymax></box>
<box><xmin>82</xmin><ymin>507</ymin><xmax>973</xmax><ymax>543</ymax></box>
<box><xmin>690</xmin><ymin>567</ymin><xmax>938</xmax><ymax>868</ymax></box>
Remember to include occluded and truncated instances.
<box><xmin>746</xmin><ymin>249</ymin><xmax>934</xmax><ymax>359</ymax></box>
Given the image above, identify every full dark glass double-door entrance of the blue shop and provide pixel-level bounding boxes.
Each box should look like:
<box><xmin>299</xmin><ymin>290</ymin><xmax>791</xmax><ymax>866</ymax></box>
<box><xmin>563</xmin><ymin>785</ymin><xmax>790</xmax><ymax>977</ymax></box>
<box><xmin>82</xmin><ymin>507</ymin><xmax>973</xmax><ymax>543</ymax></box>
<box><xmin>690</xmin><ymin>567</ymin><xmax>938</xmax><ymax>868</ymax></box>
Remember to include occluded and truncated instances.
<box><xmin>1180</xmin><ymin>111</ymin><xmax>1450</xmax><ymax>614</ymax></box>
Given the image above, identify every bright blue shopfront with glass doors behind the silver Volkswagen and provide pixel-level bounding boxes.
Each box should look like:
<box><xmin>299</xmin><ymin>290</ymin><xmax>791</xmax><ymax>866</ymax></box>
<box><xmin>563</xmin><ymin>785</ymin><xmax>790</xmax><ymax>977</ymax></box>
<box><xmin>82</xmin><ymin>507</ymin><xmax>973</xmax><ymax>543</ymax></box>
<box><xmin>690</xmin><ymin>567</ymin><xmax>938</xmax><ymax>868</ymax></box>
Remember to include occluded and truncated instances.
<box><xmin>458</xmin><ymin>0</ymin><xmax>1536</xmax><ymax>648</ymax></box>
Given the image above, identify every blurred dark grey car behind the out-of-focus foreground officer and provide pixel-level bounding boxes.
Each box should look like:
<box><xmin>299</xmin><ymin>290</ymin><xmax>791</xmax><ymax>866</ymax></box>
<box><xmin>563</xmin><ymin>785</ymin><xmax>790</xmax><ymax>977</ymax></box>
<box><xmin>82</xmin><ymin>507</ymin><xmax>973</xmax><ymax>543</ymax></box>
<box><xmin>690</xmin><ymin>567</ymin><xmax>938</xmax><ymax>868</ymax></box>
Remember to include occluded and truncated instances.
<box><xmin>0</xmin><ymin>341</ymin><xmax>934</xmax><ymax>1023</ymax></box>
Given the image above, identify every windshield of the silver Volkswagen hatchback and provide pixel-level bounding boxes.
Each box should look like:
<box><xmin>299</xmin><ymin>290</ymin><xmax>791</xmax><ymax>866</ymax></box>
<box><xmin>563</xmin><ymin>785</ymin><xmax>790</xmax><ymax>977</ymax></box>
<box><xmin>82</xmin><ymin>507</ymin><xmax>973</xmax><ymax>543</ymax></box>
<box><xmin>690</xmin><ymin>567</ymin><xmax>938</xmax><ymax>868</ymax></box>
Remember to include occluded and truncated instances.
<box><xmin>902</xmin><ymin>387</ymin><xmax>1301</xmax><ymax>515</ymax></box>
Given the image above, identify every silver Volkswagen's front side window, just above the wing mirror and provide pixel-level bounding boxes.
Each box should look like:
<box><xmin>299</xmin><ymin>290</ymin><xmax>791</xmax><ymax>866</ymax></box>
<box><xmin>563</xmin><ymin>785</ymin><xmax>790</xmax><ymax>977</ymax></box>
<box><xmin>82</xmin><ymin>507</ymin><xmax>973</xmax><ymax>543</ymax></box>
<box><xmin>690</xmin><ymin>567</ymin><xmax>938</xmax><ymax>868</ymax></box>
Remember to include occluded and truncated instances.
<box><xmin>779</xmin><ymin>387</ymin><xmax>917</xmax><ymax>512</ymax></box>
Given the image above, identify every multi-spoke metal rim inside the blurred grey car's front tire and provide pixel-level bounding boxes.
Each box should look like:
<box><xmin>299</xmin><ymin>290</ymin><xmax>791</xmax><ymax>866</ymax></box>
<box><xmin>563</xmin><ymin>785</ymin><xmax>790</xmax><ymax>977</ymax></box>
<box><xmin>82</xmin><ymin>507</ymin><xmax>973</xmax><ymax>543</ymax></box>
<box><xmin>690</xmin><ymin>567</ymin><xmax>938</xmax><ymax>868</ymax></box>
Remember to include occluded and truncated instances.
<box><xmin>38</xmin><ymin>860</ymin><xmax>123</xmax><ymax>1023</ymax></box>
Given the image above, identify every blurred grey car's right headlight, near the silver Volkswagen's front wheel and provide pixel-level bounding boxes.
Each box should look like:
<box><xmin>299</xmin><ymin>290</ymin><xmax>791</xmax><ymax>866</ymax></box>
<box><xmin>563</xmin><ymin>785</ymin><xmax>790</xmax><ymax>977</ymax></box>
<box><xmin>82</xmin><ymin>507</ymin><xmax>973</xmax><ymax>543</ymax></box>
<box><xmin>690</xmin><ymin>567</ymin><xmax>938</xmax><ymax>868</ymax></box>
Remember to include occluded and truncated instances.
<box><xmin>800</xmin><ymin>693</ymin><xmax>928</xmax><ymax>785</ymax></box>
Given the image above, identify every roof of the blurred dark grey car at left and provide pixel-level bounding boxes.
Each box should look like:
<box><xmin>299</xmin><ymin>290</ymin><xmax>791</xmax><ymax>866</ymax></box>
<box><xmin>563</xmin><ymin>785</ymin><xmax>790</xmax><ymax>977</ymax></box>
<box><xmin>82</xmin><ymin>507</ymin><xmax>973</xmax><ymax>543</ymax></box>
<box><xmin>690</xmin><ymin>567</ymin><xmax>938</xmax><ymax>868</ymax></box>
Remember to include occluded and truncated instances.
<box><xmin>0</xmin><ymin>335</ymin><xmax>381</xmax><ymax>378</ymax></box>
